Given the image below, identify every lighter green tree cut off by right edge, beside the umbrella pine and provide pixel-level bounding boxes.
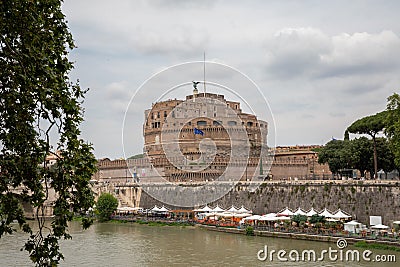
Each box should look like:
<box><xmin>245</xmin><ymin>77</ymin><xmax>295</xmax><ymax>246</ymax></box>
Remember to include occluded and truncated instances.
<box><xmin>385</xmin><ymin>93</ymin><xmax>400</xmax><ymax>169</ymax></box>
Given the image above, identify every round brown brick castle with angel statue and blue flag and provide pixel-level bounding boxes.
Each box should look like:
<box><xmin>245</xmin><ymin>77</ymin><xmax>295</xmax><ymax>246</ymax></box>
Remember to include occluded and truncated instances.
<box><xmin>143</xmin><ymin>84</ymin><xmax>268</xmax><ymax>182</ymax></box>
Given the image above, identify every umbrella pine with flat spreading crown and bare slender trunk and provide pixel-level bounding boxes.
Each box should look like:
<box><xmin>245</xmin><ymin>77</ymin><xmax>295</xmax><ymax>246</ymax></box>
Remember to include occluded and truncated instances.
<box><xmin>347</xmin><ymin>111</ymin><xmax>387</xmax><ymax>178</ymax></box>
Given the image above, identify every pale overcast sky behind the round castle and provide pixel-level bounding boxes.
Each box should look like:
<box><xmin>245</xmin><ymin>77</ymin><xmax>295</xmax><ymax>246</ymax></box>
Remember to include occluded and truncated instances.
<box><xmin>63</xmin><ymin>0</ymin><xmax>400</xmax><ymax>158</ymax></box>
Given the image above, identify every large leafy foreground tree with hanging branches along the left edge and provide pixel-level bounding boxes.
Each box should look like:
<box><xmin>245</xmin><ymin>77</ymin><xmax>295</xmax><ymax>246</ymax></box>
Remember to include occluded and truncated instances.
<box><xmin>0</xmin><ymin>0</ymin><xmax>97</xmax><ymax>266</ymax></box>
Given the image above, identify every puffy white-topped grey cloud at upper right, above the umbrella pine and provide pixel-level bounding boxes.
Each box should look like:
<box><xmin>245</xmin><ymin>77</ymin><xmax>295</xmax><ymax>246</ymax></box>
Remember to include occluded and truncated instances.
<box><xmin>265</xmin><ymin>28</ymin><xmax>400</xmax><ymax>79</ymax></box>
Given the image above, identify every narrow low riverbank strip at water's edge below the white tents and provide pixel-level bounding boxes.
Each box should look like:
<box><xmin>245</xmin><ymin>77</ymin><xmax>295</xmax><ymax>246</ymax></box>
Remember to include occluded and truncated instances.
<box><xmin>200</xmin><ymin>224</ymin><xmax>400</xmax><ymax>250</ymax></box>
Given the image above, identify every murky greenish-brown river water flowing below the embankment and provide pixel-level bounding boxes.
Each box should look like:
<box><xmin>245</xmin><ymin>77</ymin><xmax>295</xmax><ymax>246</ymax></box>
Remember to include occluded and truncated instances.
<box><xmin>0</xmin><ymin>222</ymin><xmax>400</xmax><ymax>267</ymax></box>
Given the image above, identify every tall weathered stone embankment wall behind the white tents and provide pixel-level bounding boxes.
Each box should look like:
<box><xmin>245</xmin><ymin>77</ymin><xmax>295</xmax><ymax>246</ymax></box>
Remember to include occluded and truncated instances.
<box><xmin>140</xmin><ymin>181</ymin><xmax>400</xmax><ymax>225</ymax></box>
